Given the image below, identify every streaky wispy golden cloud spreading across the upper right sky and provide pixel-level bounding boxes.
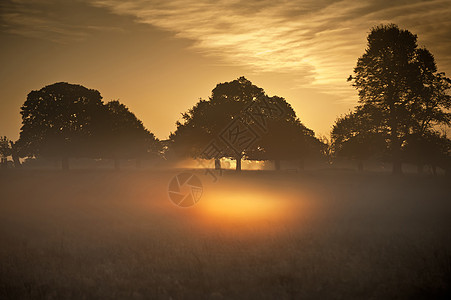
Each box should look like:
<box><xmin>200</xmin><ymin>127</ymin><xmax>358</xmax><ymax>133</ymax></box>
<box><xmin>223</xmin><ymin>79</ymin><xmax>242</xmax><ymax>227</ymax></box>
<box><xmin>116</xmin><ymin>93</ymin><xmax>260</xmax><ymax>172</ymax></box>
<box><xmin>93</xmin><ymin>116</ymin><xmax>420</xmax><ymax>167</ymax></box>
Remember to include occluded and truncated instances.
<box><xmin>91</xmin><ymin>0</ymin><xmax>451</xmax><ymax>102</ymax></box>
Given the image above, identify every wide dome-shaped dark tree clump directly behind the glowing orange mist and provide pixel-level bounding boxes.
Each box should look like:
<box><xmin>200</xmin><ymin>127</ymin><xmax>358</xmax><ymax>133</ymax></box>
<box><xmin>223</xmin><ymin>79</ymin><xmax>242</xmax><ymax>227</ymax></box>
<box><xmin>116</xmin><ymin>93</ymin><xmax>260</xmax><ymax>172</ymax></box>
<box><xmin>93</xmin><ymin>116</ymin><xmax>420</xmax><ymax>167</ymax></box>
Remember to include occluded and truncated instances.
<box><xmin>170</xmin><ymin>77</ymin><xmax>317</xmax><ymax>171</ymax></box>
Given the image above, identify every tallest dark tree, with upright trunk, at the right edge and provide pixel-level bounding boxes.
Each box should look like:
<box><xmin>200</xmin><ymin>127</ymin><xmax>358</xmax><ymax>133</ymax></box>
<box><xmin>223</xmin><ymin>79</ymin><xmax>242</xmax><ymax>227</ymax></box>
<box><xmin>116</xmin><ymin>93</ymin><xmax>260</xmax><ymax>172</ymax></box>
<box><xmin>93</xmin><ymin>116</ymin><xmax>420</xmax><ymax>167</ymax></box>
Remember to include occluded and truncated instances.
<box><xmin>348</xmin><ymin>24</ymin><xmax>451</xmax><ymax>174</ymax></box>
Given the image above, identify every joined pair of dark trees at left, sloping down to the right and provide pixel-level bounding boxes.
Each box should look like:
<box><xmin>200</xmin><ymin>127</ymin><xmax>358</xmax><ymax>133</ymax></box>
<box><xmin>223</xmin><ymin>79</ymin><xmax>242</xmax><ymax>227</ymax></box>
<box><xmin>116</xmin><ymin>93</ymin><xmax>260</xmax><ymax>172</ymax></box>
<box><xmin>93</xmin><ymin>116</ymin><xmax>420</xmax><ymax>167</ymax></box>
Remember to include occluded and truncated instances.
<box><xmin>17</xmin><ymin>82</ymin><xmax>159</xmax><ymax>169</ymax></box>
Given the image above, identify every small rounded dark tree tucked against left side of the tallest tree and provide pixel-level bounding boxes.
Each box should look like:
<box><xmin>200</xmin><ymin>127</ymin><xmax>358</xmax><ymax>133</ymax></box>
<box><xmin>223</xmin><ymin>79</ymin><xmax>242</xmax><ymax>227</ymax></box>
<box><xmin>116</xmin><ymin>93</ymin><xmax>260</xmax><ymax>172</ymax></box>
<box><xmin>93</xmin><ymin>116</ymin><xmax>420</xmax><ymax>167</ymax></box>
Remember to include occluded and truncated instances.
<box><xmin>331</xmin><ymin>105</ymin><xmax>387</xmax><ymax>171</ymax></box>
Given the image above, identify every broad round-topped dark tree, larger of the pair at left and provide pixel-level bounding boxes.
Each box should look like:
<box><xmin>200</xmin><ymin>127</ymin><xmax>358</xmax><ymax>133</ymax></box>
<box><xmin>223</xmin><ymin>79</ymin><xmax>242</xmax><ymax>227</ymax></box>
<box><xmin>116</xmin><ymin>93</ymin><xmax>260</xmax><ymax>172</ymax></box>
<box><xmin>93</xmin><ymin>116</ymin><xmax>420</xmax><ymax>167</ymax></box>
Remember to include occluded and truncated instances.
<box><xmin>17</xmin><ymin>82</ymin><xmax>105</xmax><ymax>169</ymax></box>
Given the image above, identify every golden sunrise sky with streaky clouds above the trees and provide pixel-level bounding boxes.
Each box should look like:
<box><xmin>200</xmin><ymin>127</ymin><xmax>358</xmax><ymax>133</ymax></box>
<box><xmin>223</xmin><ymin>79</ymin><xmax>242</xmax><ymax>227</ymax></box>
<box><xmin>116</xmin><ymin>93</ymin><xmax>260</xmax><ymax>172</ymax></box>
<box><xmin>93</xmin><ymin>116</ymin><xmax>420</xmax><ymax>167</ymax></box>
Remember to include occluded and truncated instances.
<box><xmin>0</xmin><ymin>0</ymin><xmax>451</xmax><ymax>140</ymax></box>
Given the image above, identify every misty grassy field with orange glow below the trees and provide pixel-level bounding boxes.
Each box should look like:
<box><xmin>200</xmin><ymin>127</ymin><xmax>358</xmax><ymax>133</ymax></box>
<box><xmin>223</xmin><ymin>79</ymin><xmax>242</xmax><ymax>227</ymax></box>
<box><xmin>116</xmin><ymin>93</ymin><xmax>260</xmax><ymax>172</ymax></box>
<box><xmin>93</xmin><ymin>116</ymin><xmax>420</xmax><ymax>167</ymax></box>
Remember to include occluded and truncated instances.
<box><xmin>0</xmin><ymin>170</ymin><xmax>451</xmax><ymax>299</ymax></box>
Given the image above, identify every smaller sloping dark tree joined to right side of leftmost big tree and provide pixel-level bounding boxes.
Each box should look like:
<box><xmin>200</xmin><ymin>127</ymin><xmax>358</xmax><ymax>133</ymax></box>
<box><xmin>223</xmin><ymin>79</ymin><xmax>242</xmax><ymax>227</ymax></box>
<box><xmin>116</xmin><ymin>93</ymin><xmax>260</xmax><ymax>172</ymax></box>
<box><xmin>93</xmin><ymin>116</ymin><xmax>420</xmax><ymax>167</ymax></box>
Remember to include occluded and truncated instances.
<box><xmin>103</xmin><ymin>100</ymin><xmax>160</xmax><ymax>169</ymax></box>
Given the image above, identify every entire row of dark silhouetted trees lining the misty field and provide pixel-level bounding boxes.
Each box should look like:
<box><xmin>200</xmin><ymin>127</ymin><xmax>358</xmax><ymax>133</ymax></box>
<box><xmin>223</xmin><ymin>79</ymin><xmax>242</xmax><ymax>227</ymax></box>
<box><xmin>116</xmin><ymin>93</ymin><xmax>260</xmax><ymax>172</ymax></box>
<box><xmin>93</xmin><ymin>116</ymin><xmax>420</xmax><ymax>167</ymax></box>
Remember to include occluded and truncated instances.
<box><xmin>0</xmin><ymin>24</ymin><xmax>451</xmax><ymax>174</ymax></box>
